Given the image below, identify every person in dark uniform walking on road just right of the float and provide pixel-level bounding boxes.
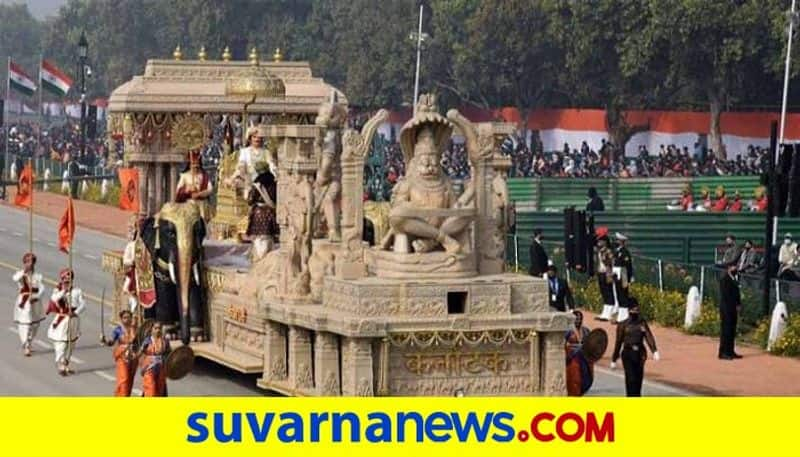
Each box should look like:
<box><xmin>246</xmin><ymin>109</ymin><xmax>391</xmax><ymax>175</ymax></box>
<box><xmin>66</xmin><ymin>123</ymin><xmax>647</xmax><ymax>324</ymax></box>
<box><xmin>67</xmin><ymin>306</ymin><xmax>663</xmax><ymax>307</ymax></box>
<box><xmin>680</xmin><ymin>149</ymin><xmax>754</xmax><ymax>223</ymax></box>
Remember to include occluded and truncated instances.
<box><xmin>611</xmin><ymin>297</ymin><xmax>661</xmax><ymax>397</ymax></box>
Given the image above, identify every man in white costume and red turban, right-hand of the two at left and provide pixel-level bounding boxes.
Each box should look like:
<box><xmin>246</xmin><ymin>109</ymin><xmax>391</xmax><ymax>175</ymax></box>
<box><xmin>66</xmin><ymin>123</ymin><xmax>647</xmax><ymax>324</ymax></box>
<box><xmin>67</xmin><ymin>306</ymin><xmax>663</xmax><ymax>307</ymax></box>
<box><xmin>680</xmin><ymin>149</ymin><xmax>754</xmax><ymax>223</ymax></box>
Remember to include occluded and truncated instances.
<box><xmin>47</xmin><ymin>268</ymin><xmax>86</xmax><ymax>376</ymax></box>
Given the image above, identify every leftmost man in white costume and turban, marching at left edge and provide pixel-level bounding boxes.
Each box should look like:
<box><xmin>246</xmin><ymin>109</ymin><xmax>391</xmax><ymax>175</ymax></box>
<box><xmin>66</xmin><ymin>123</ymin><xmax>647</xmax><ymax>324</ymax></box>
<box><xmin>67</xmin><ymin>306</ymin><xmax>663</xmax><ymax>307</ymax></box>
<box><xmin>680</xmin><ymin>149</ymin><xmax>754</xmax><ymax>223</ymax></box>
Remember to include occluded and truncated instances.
<box><xmin>12</xmin><ymin>252</ymin><xmax>44</xmax><ymax>357</ymax></box>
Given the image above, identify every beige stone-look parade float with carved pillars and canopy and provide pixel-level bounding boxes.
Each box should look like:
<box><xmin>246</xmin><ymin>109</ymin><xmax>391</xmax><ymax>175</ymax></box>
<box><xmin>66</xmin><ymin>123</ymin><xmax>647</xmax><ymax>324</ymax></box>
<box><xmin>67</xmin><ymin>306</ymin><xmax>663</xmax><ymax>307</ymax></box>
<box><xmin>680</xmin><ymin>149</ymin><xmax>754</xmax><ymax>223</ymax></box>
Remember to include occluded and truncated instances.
<box><xmin>103</xmin><ymin>48</ymin><xmax>572</xmax><ymax>396</ymax></box>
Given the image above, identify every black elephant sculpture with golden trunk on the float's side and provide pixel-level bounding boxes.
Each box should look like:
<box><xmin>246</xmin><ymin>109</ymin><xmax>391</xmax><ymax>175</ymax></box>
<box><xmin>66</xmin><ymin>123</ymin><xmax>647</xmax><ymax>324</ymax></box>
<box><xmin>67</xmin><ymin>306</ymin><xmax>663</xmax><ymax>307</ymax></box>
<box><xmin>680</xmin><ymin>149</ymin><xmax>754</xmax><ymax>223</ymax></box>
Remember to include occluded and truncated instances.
<box><xmin>142</xmin><ymin>202</ymin><xmax>206</xmax><ymax>344</ymax></box>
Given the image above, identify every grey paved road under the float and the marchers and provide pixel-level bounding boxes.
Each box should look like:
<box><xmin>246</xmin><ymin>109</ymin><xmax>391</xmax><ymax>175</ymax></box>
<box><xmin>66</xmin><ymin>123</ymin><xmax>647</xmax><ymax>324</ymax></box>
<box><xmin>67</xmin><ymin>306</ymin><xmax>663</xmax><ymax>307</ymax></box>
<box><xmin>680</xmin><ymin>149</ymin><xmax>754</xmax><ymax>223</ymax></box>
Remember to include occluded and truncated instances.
<box><xmin>0</xmin><ymin>206</ymin><xmax>690</xmax><ymax>396</ymax></box>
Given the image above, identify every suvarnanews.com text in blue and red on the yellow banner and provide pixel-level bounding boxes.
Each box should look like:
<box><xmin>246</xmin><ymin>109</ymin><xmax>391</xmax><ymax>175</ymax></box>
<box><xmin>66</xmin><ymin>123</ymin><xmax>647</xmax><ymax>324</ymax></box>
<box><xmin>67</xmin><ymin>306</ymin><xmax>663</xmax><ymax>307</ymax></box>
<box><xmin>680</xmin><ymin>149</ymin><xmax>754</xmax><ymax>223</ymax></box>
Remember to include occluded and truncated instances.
<box><xmin>186</xmin><ymin>411</ymin><xmax>615</xmax><ymax>443</ymax></box>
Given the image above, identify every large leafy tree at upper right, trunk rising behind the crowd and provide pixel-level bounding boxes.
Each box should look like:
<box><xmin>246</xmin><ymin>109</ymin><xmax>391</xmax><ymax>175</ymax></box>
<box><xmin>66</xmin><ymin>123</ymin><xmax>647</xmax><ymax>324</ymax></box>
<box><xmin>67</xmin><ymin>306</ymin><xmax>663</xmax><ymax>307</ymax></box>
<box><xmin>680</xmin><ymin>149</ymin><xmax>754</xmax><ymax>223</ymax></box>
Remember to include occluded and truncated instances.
<box><xmin>626</xmin><ymin>0</ymin><xmax>785</xmax><ymax>157</ymax></box>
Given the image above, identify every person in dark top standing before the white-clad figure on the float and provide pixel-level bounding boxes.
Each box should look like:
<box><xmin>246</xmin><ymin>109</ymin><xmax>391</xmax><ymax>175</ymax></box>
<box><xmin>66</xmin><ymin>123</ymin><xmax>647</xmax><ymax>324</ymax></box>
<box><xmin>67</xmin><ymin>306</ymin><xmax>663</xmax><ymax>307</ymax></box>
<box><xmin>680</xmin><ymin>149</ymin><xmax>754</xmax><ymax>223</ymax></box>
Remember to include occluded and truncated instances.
<box><xmin>247</xmin><ymin>161</ymin><xmax>278</xmax><ymax>260</ymax></box>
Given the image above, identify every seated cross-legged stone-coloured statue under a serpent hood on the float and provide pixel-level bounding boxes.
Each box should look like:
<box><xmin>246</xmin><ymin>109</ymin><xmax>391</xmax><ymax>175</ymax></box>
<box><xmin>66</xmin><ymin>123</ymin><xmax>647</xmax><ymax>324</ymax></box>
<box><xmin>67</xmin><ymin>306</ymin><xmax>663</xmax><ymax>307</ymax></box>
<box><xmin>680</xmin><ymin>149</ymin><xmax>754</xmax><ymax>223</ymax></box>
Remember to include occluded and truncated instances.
<box><xmin>381</xmin><ymin>95</ymin><xmax>475</xmax><ymax>254</ymax></box>
